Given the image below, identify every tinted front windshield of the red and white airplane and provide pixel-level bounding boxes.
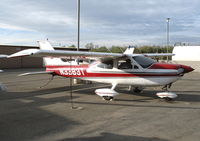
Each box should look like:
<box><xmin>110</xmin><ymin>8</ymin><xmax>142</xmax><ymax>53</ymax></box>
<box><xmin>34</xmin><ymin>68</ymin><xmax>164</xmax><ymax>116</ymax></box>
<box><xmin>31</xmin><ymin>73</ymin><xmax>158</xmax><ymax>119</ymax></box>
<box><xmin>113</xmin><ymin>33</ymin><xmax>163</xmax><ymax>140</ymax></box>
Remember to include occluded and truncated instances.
<box><xmin>133</xmin><ymin>56</ymin><xmax>156</xmax><ymax>68</ymax></box>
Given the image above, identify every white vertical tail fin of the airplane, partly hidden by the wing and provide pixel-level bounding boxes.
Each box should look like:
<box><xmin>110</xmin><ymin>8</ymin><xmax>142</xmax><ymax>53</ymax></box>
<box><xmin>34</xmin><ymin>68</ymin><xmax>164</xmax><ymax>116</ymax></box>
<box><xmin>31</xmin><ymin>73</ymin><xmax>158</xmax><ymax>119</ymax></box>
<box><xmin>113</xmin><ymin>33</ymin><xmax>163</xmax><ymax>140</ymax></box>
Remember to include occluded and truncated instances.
<box><xmin>38</xmin><ymin>41</ymin><xmax>70</xmax><ymax>66</ymax></box>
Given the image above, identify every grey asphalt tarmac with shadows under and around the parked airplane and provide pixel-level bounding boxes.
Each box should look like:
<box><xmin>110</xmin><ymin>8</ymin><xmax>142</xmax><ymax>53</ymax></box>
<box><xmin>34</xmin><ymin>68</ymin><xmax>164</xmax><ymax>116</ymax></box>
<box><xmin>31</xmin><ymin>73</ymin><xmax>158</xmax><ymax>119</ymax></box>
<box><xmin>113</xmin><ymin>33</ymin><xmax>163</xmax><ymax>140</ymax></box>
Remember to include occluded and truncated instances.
<box><xmin>0</xmin><ymin>69</ymin><xmax>200</xmax><ymax>141</ymax></box>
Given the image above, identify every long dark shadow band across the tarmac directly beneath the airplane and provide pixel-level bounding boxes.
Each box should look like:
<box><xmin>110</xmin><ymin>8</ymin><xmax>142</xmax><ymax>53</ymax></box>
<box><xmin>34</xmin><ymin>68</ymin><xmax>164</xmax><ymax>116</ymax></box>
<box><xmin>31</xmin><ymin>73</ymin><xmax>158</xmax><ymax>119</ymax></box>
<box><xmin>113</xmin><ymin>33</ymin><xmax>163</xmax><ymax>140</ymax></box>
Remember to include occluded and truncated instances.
<box><xmin>0</xmin><ymin>83</ymin><xmax>200</xmax><ymax>102</ymax></box>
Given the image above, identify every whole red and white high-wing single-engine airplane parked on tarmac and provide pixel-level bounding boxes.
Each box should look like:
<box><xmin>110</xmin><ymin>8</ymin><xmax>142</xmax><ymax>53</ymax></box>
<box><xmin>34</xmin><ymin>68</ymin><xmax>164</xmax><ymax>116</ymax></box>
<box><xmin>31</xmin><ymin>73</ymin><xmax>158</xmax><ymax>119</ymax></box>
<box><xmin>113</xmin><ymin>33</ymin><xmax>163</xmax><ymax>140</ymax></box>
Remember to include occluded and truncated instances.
<box><xmin>7</xmin><ymin>41</ymin><xmax>194</xmax><ymax>100</ymax></box>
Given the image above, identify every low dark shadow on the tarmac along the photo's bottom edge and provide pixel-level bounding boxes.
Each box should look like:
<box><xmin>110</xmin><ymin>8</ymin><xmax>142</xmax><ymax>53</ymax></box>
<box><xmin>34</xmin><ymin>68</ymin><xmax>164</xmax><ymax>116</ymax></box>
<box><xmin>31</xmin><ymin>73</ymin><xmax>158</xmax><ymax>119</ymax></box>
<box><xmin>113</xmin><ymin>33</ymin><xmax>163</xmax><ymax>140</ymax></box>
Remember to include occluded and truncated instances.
<box><xmin>58</xmin><ymin>132</ymin><xmax>168</xmax><ymax>141</ymax></box>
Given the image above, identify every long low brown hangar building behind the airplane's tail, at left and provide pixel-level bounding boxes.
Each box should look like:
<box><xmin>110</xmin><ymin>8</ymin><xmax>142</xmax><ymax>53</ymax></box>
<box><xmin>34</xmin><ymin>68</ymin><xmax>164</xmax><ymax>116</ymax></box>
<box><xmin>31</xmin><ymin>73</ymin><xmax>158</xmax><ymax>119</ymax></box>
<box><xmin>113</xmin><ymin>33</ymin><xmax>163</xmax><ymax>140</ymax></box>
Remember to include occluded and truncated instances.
<box><xmin>0</xmin><ymin>45</ymin><xmax>89</xmax><ymax>69</ymax></box>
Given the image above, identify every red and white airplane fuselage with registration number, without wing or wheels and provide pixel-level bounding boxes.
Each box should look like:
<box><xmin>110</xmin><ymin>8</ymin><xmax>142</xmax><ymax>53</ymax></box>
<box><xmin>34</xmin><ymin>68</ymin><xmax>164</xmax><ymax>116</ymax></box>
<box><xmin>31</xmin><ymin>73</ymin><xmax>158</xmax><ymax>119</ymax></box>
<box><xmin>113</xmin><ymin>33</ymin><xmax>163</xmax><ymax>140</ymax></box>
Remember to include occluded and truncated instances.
<box><xmin>46</xmin><ymin>57</ymin><xmax>192</xmax><ymax>87</ymax></box>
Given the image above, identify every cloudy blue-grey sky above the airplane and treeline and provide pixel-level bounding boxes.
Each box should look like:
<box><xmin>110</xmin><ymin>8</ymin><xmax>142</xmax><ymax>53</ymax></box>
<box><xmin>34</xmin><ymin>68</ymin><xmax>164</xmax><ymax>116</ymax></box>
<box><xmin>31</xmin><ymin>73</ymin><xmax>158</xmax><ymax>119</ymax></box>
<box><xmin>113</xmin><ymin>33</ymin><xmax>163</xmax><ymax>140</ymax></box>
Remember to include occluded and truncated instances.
<box><xmin>0</xmin><ymin>0</ymin><xmax>200</xmax><ymax>47</ymax></box>
